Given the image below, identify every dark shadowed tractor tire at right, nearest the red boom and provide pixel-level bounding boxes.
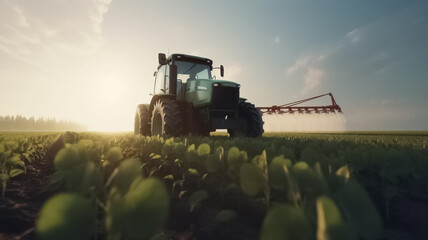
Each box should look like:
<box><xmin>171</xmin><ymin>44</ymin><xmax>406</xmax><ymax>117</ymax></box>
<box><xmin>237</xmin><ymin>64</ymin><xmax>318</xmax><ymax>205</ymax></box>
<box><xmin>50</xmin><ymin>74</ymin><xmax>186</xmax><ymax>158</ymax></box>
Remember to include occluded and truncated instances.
<box><xmin>227</xmin><ymin>102</ymin><xmax>264</xmax><ymax>137</ymax></box>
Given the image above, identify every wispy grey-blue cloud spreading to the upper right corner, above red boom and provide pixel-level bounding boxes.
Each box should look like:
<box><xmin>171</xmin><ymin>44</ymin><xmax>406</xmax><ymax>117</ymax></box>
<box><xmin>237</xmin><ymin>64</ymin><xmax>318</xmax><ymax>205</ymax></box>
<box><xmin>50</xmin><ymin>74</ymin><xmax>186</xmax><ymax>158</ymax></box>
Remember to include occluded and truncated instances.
<box><xmin>285</xmin><ymin>1</ymin><xmax>428</xmax><ymax>97</ymax></box>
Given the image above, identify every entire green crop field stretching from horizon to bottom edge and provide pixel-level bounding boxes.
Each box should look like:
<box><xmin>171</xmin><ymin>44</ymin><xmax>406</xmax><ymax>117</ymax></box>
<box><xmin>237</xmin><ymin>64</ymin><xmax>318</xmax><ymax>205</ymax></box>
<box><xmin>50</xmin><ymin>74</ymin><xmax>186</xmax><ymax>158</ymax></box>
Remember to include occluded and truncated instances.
<box><xmin>0</xmin><ymin>132</ymin><xmax>428</xmax><ymax>239</ymax></box>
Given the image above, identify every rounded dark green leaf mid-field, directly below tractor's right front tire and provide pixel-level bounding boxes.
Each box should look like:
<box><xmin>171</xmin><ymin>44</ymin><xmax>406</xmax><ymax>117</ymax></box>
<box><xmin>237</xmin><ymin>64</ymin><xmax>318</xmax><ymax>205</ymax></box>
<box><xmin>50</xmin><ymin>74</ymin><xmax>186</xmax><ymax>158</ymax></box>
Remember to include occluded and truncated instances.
<box><xmin>239</xmin><ymin>163</ymin><xmax>266</xmax><ymax>196</ymax></box>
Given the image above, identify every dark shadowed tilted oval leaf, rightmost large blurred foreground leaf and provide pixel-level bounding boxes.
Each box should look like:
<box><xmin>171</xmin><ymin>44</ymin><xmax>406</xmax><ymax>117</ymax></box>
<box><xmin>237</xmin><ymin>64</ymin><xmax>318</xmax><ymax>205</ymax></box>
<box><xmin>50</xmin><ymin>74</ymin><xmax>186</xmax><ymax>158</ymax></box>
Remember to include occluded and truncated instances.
<box><xmin>337</xmin><ymin>179</ymin><xmax>383</xmax><ymax>239</ymax></box>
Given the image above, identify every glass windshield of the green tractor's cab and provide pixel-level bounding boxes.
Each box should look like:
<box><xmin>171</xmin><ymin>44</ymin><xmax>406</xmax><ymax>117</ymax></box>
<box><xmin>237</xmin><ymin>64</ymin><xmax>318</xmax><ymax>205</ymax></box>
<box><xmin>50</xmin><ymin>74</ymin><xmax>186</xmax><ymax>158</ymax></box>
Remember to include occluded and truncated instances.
<box><xmin>175</xmin><ymin>61</ymin><xmax>211</xmax><ymax>83</ymax></box>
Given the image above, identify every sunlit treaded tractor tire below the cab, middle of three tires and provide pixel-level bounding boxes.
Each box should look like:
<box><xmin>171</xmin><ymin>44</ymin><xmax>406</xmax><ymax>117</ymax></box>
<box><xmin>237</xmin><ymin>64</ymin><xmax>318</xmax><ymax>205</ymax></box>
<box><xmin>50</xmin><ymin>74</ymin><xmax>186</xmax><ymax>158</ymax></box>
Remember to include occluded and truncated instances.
<box><xmin>151</xmin><ymin>99</ymin><xmax>185</xmax><ymax>136</ymax></box>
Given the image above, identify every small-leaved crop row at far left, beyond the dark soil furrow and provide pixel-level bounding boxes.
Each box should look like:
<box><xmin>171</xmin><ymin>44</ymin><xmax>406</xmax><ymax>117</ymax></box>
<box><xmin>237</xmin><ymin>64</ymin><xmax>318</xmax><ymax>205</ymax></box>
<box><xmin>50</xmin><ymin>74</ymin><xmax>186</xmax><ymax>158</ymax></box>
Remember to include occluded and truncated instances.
<box><xmin>0</xmin><ymin>133</ymin><xmax>59</xmax><ymax>197</ymax></box>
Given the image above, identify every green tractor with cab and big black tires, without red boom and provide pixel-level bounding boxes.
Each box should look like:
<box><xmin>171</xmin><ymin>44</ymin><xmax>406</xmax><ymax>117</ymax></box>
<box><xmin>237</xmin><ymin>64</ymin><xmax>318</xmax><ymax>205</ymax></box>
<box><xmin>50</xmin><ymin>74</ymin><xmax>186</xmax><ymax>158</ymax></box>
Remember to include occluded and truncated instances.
<box><xmin>134</xmin><ymin>53</ymin><xmax>263</xmax><ymax>137</ymax></box>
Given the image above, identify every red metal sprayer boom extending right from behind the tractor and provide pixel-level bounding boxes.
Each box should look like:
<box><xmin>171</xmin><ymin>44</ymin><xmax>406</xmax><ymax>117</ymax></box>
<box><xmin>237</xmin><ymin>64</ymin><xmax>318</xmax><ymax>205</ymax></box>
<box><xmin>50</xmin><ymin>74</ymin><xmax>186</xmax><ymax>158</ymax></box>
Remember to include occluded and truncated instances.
<box><xmin>257</xmin><ymin>93</ymin><xmax>342</xmax><ymax>114</ymax></box>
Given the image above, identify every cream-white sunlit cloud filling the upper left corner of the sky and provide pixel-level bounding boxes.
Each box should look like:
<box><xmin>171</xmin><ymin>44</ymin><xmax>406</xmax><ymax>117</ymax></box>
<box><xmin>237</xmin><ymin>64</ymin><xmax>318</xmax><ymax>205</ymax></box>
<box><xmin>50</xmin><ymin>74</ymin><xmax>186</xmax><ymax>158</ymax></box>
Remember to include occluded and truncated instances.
<box><xmin>0</xmin><ymin>0</ymin><xmax>111</xmax><ymax>69</ymax></box>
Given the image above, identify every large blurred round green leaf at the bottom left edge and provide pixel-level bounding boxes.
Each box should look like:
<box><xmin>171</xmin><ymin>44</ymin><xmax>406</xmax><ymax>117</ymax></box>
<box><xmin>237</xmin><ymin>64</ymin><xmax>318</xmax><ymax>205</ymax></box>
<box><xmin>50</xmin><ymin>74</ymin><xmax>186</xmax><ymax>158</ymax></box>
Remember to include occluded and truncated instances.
<box><xmin>36</xmin><ymin>193</ymin><xmax>95</xmax><ymax>240</ymax></box>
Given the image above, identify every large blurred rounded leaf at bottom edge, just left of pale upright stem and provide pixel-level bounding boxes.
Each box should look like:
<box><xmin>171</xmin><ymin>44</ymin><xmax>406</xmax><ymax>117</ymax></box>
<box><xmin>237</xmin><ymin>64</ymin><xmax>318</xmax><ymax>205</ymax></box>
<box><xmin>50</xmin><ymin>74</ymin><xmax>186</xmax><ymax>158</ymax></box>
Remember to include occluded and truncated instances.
<box><xmin>260</xmin><ymin>204</ymin><xmax>314</xmax><ymax>240</ymax></box>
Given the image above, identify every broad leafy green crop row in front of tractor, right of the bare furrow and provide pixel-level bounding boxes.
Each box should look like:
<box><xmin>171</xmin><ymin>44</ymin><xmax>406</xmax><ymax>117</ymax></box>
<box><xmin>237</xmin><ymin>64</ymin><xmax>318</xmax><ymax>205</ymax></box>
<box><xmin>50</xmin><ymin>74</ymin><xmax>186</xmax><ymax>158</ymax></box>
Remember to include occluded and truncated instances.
<box><xmin>37</xmin><ymin>133</ymin><xmax>428</xmax><ymax>239</ymax></box>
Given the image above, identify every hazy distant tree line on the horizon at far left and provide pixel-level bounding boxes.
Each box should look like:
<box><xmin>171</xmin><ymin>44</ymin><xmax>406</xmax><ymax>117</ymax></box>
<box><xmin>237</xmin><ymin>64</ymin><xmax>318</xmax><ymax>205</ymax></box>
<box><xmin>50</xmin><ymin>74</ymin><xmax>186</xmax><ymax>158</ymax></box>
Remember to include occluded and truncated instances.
<box><xmin>0</xmin><ymin>115</ymin><xmax>87</xmax><ymax>131</ymax></box>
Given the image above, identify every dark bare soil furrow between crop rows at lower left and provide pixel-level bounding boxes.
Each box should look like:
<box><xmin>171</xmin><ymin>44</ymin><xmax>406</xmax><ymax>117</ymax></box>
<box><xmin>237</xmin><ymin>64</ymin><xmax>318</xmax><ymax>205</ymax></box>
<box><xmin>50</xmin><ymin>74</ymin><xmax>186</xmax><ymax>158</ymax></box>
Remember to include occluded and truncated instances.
<box><xmin>0</xmin><ymin>138</ymin><xmax>64</xmax><ymax>240</ymax></box>
